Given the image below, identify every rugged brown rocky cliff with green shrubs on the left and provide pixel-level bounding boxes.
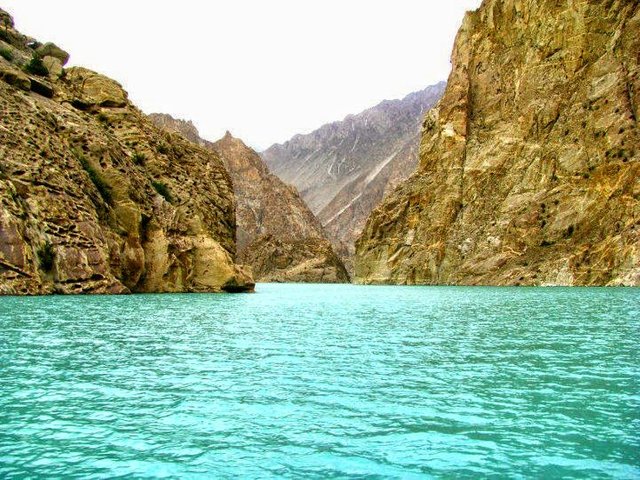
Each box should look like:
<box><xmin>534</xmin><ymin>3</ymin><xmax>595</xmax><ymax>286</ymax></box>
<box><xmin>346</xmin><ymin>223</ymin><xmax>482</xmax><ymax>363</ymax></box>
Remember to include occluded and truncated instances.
<box><xmin>0</xmin><ymin>10</ymin><xmax>253</xmax><ymax>294</ymax></box>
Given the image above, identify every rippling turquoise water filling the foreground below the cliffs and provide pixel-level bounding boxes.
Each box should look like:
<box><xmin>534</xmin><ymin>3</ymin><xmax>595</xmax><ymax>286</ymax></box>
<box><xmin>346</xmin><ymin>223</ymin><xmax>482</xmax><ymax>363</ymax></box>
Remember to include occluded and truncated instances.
<box><xmin>0</xmin><ymin>284</ymin><xmax>640</xmax><ymax>478</ymax></box>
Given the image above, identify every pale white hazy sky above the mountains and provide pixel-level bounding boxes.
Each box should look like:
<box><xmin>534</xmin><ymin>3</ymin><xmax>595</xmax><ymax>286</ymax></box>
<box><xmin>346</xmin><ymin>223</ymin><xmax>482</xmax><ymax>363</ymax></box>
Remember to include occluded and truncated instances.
<box><xmin>1</xmin><ymin>0</ymin><xmax>480</xmax><ymax>149</ymax></box>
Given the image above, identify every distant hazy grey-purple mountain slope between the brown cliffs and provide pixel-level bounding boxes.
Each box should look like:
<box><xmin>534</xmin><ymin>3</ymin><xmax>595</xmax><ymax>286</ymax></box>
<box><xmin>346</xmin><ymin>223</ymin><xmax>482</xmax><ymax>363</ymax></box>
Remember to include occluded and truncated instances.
<box><xmin>261</xmin><ymin>83</ymin><xmax>445</xmax><ymax>270</ymax></box>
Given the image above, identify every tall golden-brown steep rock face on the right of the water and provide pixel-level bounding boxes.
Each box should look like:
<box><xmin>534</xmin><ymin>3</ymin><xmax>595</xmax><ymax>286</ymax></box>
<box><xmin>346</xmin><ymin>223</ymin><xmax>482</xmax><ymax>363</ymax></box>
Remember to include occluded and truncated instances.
<box><xmin>355</xmin><ymin>0</ymin><xmax>640</xmax><ymax>285</ymax></box>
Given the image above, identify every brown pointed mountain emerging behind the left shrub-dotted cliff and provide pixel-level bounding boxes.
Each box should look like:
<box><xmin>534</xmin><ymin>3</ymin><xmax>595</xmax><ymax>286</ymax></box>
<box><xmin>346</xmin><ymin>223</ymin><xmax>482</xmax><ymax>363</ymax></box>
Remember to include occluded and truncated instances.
<box><xmin>150</xmin><ymin>114</ymin><xmax>349</xmax><ymax>283</ymax></box>
